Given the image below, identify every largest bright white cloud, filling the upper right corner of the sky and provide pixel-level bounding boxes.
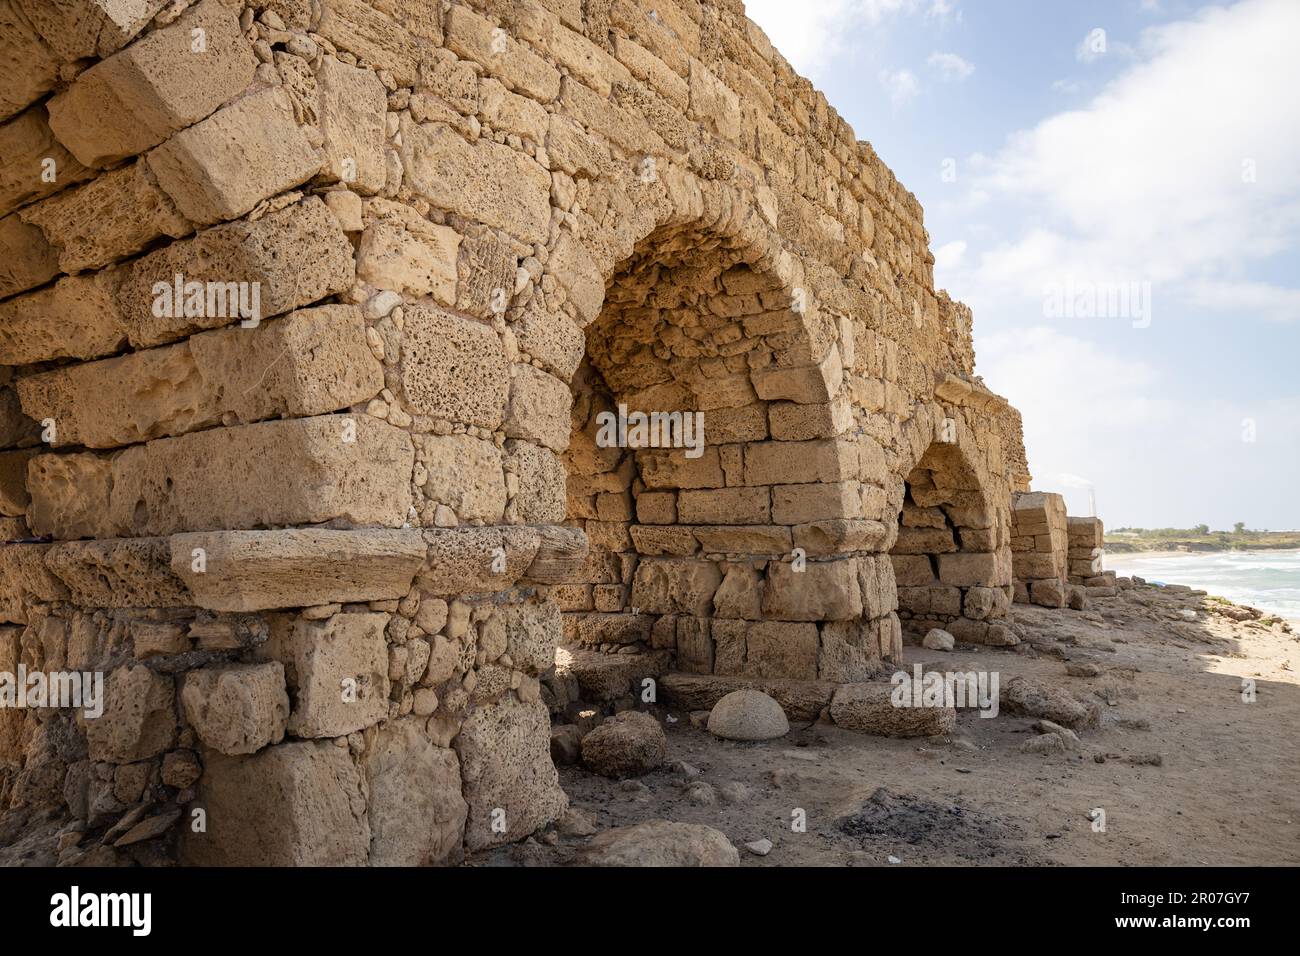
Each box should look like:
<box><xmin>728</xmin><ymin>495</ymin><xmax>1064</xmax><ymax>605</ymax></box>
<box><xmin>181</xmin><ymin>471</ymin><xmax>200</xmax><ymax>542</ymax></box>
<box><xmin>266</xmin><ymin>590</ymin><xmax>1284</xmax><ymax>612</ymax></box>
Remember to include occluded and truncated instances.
<box><xmin>957</xmin><ymin>0</ymin><xmax>1300</xmax><ymax>320</ymax></box>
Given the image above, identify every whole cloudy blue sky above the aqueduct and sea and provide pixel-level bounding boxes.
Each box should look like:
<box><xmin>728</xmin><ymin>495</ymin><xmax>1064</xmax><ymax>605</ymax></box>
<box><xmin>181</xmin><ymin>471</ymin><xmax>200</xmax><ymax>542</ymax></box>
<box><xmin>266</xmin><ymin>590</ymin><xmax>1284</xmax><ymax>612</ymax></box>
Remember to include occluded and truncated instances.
<box><xmin>746</xmin><ymin>0</ymin><xmax>1300</xmax><ymax>531</ymax></box>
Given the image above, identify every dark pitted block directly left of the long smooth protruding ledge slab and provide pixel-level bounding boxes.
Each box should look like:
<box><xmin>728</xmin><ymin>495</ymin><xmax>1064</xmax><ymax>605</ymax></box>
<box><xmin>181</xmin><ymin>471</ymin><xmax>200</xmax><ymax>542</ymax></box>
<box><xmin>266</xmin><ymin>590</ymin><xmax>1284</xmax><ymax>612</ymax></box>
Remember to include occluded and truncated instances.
<box><xmin>46</xmin><ymin>537</ymin><xmax>191</xmax><ymax>607</ymax></box>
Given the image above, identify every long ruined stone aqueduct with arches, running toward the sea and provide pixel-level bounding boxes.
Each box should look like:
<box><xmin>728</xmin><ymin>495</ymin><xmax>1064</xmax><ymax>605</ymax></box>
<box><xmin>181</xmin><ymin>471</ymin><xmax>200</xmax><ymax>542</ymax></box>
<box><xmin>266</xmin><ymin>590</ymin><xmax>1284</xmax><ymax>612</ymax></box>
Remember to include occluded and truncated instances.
<box><xmin>0</xmin><ymin>0</ymin><xmax>1105</xmax><ymax>864</ymax></box>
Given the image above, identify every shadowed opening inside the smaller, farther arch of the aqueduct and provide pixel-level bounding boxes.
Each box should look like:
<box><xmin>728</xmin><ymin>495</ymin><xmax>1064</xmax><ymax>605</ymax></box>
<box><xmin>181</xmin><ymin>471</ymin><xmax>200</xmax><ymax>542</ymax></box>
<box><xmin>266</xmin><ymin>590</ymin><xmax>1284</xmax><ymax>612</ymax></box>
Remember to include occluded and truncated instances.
<box><xmin>889</xmin><ymin>441</ymin><xmax>1014</xmax><ymax>644</ymax></box>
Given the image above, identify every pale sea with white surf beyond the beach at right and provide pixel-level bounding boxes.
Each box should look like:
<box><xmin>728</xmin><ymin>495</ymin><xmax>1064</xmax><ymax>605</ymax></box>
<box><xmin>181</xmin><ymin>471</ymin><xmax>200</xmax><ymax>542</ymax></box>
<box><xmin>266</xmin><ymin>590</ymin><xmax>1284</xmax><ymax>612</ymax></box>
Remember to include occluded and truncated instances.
<box><xmin>1105</xmin><ymin>550</ymin><xmax>1300</xmax><ymax>622</ymax></box>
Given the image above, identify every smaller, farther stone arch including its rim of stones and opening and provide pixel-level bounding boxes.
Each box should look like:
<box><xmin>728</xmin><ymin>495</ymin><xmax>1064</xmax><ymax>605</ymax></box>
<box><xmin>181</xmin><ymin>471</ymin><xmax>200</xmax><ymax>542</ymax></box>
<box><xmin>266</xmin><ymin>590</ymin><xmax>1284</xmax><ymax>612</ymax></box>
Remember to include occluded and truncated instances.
<box><xmin>889</xmin><ymin>405</ymin><xmax>1015</xmax><ymax>644</ymax></box>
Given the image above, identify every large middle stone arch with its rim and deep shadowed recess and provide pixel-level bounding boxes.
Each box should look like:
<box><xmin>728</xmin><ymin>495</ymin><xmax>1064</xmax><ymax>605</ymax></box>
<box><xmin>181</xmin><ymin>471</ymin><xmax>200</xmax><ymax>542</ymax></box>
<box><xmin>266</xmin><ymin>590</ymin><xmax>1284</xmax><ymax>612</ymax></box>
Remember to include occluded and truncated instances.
<box><xmin>538</xmin><ymin>170</ymin><xmax>897</xmax><ymax>697</ymax></box>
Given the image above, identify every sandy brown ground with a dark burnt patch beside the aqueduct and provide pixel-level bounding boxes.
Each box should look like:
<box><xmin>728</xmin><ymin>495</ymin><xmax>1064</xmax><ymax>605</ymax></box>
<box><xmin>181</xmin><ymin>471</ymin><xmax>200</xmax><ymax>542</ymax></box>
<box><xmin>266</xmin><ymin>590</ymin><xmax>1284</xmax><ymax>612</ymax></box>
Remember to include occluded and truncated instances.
<box><xmin>486</xmin><ymin>588</ymin><xmax>1300</xmax><ymax>866</ymax></box>
